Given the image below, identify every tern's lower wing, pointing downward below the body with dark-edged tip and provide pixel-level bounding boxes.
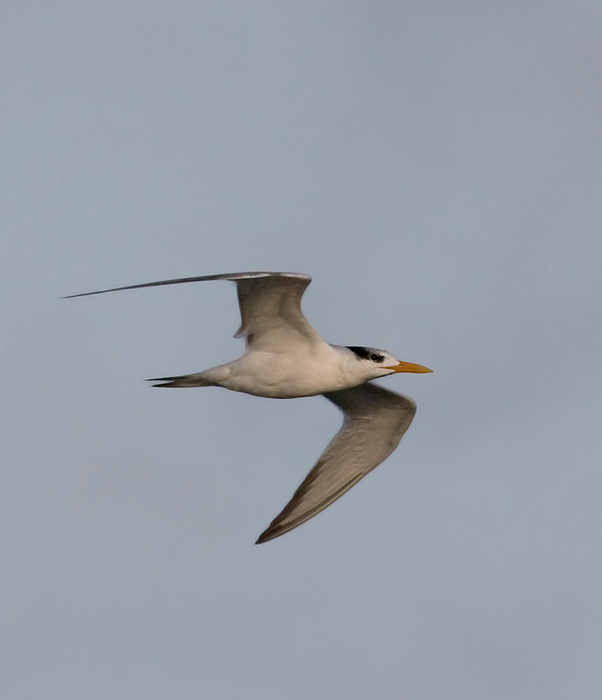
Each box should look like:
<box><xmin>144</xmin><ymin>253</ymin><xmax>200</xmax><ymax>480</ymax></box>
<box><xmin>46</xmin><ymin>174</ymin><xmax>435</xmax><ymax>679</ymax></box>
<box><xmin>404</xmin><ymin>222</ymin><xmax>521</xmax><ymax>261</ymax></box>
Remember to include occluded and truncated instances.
<box><xmin>256</xmin><ymin>384</ymin><xmax>416</xmax><ymax>544</ymax></box>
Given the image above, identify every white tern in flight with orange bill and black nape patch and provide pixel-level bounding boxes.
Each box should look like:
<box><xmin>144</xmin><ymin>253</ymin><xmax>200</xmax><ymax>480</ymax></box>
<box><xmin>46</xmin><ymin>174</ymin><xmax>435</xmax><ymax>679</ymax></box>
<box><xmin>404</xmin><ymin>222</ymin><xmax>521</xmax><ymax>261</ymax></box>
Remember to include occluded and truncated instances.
<box><xmin>65</xmin><ymin>272</ymin><xmax>432</xmax><ymax>544</ymax></box>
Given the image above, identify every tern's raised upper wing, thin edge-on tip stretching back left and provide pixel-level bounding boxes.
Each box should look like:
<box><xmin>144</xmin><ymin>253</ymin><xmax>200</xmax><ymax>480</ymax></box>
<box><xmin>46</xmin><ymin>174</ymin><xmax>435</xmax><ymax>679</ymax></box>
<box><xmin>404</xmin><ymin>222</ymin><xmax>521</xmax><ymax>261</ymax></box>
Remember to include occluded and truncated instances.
<box><xmin>65</xmin><ymin>272</ymin><xmax>320</xmax><ymax>349</ymax></box>
